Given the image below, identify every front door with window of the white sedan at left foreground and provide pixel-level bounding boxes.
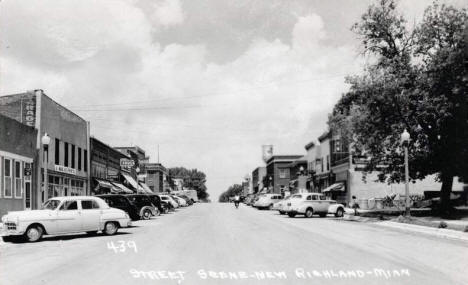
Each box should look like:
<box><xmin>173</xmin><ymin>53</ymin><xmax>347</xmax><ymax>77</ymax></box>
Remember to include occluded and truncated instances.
<box><xmin>56</xmin><ymin>200</ymin><xmax>81</xmax><ymax>233</ymax></box>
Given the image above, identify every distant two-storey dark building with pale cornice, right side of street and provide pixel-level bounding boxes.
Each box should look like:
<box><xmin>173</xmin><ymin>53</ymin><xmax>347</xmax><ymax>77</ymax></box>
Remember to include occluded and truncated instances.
<box><xmin>264</xmin><ymin>155</ymin><xmax>302</xmax><ymax>194</ymax></box>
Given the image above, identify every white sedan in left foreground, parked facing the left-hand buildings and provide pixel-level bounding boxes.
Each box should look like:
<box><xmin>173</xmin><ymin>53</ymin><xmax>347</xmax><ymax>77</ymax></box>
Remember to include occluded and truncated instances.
<box><xmin>0</xmin><ymin>196</ymin><xmax>131</xmax><ymax>242</ymax></box>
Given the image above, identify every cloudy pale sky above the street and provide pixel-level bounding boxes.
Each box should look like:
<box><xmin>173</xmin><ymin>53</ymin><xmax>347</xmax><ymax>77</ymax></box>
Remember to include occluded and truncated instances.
<box><xmin>0</xmin><ymin>0</ymin><xmax>466</xmax><ymax>200</ymax></box>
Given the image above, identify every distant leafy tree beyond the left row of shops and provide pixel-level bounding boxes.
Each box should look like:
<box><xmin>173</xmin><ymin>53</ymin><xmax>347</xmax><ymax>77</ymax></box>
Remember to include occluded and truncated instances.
<box><xmin>168</xmin><ymin>167</ymin><xmax>210</xmax><ymax>200</ymax></box>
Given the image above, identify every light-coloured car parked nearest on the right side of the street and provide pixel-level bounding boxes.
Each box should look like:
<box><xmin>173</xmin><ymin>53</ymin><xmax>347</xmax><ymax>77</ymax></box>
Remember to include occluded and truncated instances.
<box><xmin>283</xmin><ymin>193</ymin><xmax>345</xmax><ymax>218</ymax></box>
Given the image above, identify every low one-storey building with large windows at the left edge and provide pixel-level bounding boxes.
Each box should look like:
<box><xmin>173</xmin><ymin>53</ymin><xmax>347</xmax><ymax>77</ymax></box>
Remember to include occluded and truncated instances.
<box><xmin>0</xmin><ymin>115</ymin><xmax>37</xmax><ymax>217</ymax></box>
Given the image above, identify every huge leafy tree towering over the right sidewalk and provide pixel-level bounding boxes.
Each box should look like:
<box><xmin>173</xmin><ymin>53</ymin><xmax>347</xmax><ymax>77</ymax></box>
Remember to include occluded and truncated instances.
<box><xmin>329</xmin><ymin>0</ymin><xmax>468</xmax><ymax>214</ymax></box>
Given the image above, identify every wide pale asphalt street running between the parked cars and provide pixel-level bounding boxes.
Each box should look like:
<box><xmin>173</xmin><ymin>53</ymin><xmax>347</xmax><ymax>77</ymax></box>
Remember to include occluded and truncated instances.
<box><xmin>0</xmin><ymin>204</ymin><xmax>468</xmax><ymax>285</ymax></box>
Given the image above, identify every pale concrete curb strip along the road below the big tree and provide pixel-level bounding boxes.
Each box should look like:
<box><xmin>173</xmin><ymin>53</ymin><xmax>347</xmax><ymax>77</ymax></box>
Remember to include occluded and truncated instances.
<box><xmin>374</xmin><ymin>221</ymin><xmax>468</xmax><ymax>242</ymax></box>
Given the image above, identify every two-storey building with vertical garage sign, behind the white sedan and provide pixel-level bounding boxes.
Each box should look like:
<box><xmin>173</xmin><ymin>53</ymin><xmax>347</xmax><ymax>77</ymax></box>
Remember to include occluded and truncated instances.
<box><xmin>0</xmin><ymin>90</ymin><xmax>90</xmax><ymax>208</ymax></box>
